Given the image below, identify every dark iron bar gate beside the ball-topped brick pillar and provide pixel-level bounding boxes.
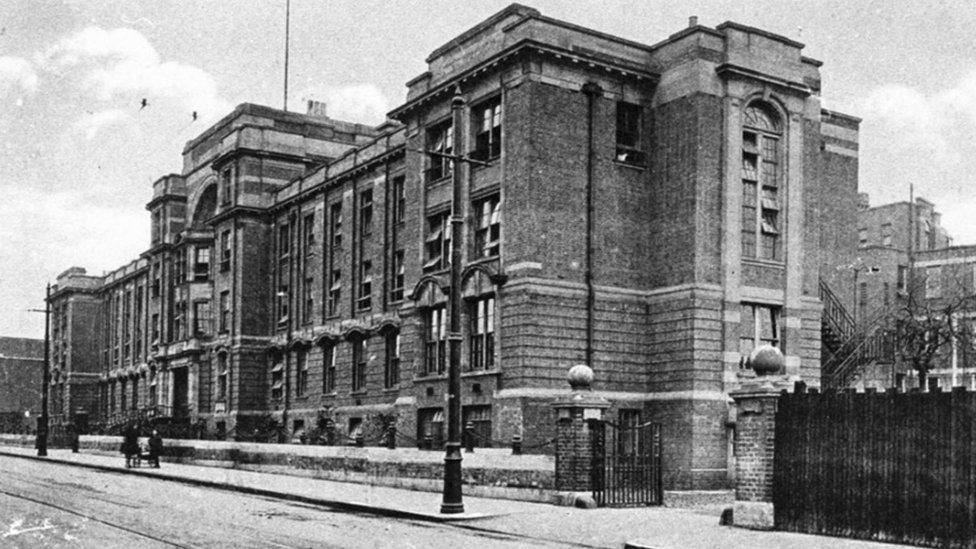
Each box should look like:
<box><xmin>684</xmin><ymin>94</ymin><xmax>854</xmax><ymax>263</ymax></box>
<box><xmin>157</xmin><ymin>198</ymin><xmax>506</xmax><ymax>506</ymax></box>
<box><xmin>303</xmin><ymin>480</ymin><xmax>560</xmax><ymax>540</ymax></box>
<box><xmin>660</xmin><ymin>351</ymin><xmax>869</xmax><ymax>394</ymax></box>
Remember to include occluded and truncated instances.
<box><xmin>590</xmin><ymin>420</ymin><xmax>663</xmax><ymax>507</ymax></box>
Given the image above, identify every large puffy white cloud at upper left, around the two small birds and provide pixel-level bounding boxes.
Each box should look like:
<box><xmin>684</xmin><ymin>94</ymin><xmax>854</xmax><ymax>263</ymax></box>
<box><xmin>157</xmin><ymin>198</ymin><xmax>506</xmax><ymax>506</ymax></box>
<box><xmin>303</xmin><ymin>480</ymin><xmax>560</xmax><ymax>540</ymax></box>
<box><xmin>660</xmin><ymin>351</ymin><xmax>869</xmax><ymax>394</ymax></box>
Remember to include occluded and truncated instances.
<box><xmin>37</xmin><ymin>27</ymin><xmax>230</xmax><ymax>119</ymax></box>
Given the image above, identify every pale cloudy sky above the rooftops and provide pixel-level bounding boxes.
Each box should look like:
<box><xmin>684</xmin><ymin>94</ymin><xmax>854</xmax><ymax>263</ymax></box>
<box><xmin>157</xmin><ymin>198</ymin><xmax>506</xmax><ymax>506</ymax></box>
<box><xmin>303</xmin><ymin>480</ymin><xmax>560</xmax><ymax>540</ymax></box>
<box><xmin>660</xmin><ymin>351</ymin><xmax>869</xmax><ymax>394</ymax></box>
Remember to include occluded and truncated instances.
<box><xmin>0</xmin><ymin>0</ymin><xmax>976</xmax><ymax>337</ymax></box>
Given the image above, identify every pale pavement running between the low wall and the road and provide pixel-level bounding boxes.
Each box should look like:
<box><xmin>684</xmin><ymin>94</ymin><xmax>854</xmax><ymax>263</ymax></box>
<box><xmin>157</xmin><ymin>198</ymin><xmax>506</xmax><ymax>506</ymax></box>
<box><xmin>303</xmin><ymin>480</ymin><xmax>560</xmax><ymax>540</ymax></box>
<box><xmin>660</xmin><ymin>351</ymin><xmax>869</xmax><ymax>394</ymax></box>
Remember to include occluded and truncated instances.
<box><xmin>0</xmin><ymin>446</ymin><xmax>896</xmax><ymax>549</ymax></box>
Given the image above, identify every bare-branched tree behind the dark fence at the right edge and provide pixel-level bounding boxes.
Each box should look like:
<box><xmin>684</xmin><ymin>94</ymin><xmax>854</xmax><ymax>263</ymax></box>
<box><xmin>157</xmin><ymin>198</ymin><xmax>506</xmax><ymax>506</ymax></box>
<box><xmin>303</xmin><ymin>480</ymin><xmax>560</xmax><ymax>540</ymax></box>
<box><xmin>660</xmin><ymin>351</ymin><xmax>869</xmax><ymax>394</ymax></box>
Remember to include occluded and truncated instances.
<box><xmin>892</xmin><ymin>276</ymin><xmax>976</xmax><ymax>389</ymax></box>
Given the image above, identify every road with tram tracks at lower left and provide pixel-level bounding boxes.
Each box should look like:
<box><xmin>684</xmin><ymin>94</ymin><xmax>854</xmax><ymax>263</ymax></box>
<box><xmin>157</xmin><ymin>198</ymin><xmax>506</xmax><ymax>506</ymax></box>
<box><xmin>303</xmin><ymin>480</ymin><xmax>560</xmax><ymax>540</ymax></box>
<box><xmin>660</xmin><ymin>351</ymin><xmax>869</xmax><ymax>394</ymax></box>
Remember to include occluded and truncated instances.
<box><xmin>0</xmin><ymin>456</ymin><xmax>566</xmax><ymax>548</ymax></box>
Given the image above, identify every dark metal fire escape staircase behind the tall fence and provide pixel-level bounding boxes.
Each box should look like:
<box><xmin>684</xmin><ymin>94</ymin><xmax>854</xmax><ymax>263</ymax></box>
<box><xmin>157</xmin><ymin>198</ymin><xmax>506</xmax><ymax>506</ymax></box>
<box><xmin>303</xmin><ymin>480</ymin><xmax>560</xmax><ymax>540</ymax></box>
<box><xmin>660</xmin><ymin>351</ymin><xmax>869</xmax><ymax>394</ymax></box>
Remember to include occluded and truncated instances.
<box><xmin>820</xmin><ymin>280</ymin><xmax>894</xmax><ymax>389</ymax></box>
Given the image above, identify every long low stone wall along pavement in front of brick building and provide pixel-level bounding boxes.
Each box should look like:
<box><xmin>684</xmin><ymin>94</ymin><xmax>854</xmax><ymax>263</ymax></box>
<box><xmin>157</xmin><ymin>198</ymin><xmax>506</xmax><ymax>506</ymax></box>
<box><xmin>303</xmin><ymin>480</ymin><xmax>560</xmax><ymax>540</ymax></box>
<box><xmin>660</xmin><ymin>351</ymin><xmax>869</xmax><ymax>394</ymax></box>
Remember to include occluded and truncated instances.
<box><xmin>0</xmin><ymin>435</ymin><xmax>564</xmax><ymax>503</ymax></box>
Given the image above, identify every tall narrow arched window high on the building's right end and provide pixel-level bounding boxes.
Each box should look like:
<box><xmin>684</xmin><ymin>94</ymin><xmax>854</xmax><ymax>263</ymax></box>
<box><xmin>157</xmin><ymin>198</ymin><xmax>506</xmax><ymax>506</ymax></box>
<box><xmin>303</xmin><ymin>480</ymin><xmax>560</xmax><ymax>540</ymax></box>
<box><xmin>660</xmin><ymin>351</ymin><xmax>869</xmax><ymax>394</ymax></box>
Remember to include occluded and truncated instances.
<box><xmin>742</xmin><ymin>104</ymin><xmax>782</xmax><ymax>260</ymax></box>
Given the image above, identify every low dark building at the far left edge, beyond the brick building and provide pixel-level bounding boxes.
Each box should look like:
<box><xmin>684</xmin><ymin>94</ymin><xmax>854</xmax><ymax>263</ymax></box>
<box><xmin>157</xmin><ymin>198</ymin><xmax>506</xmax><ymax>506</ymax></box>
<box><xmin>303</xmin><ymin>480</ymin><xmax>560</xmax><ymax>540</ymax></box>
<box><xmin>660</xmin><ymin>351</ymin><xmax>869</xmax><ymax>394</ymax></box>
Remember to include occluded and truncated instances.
<box><xmin>0</xmin><ymin>337</ymin><xmax>44</xmax><ymax>433</ymax></box>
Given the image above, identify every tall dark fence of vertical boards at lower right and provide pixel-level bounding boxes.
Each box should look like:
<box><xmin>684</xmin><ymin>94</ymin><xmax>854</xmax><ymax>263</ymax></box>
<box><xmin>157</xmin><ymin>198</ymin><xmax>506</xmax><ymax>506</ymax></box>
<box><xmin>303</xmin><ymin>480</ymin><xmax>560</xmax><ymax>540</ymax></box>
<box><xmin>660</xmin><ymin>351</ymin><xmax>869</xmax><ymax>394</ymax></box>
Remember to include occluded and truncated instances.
<box><xmin>773</xmin><ymin>390</ymin><xmax>976</xmax><ymax>547</ymax></box>
